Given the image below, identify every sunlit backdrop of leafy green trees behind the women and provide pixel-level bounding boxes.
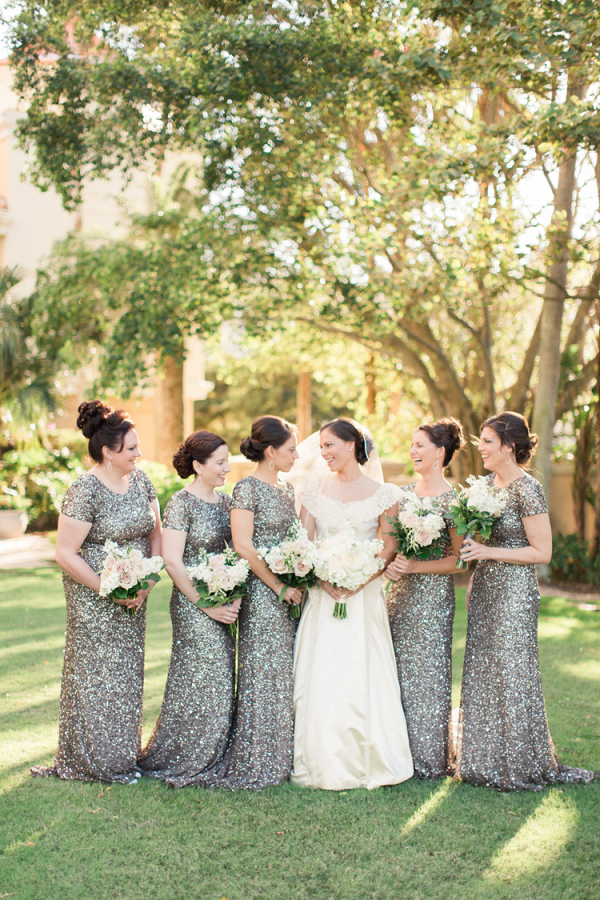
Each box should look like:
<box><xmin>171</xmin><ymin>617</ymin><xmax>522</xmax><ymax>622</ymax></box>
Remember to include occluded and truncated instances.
<box><xmin>0</xmin><ymin>0</ymin><xmax>600</xmax><ymax>580</ymax></box>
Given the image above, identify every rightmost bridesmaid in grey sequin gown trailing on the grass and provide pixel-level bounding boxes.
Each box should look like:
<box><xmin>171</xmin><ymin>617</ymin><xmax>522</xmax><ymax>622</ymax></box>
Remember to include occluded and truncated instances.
<box><xmin>456</xmin><ymin>412</ymin><xmax>594</xmax><ymax>791</ymax></box>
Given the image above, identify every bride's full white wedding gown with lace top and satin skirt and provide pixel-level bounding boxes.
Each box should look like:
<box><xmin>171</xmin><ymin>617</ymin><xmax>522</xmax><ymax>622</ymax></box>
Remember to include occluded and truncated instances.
<box><xmin>292</xmin><ymin>480</ymin><xmax>413</xmax><ymax>791</ymax></box>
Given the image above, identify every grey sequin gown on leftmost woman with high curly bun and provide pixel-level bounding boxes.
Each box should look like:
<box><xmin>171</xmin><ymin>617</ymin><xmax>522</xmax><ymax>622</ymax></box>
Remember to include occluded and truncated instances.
<box><xmin>32</xmin><ymin>469</ymin><xmax>156</xmax><ymax>783</ymax></box>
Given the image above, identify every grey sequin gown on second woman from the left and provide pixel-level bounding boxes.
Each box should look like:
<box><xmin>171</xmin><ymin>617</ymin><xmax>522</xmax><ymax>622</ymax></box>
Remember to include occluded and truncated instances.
<box><xmin>138</xmin><ymin>490</ymin><xmax>233</xmax><ymax>787</ymax></box>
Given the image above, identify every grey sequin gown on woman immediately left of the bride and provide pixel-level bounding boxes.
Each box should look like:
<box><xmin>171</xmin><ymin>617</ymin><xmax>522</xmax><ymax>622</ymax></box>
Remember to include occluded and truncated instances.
<box><xmin>199</xmin><ymin>475</ymin><xmax>297</xmax><ymax>790</ymax></box>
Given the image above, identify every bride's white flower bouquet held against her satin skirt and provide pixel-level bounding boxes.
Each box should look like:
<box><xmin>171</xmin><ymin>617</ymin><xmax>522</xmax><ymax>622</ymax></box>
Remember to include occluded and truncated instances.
<box><xmin>314</xmin><ymin>520</ymin><xmax>384</xmax><ymax>619</ymax></box>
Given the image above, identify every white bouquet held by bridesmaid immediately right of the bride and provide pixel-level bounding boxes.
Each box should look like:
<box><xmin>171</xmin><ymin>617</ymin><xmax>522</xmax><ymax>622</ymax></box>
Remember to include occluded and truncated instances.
<box><xmin>388</xmin><ymin>492</ymin><xmax>448</xmax><ymax>559</ymax></box>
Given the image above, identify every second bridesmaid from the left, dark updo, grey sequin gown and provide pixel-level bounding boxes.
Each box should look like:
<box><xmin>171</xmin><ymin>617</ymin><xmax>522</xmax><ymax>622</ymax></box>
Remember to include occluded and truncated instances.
<box><xmin>138</xmin><ymin>431</ymin><xmax>241</xmax><ymax>787</ymax></box>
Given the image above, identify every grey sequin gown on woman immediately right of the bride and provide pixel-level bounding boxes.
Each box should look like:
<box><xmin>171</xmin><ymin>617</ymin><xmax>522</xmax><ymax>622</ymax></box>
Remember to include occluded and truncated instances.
<box><xmin>387</xmin><ymin>484</ymin><xmax>456</xmax><ymax>778</ymax></box>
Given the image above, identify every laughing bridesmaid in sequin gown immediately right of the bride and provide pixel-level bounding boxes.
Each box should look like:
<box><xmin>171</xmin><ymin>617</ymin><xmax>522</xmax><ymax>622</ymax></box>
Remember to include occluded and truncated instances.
<box><xmin>386</xmin><ymin>418</ymin><xmax>465</xmax><ymax>778</ymax></box>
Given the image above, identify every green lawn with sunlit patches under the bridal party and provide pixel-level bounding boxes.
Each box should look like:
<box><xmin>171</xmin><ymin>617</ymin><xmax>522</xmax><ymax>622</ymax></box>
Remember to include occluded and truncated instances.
<box><xmin>0</xmin><ymin>569</ymin><xmax>600</xmax><ymax>900</ymax></box>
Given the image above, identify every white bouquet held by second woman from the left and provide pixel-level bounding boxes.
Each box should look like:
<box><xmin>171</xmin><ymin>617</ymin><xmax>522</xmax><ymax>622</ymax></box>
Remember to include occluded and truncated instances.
<box><xmin>185</xmin><ymin>545</ymin><xmax>250</xmax><ymax>638</ymax></box>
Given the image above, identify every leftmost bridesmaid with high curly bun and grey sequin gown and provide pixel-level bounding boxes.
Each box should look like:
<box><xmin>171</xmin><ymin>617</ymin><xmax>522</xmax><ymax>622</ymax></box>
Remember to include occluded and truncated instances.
<box><xmin>32</xmin><ymin>400</ymin><xmax>160</xmax><ymax>784</ymax></box>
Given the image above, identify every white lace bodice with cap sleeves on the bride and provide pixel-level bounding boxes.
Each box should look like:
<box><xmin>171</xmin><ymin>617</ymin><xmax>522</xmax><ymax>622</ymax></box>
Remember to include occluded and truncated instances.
<box><xmin>302</xmin><ymin>479</ymin><xmax>397</xmax><ymax>541</ymax></box>
